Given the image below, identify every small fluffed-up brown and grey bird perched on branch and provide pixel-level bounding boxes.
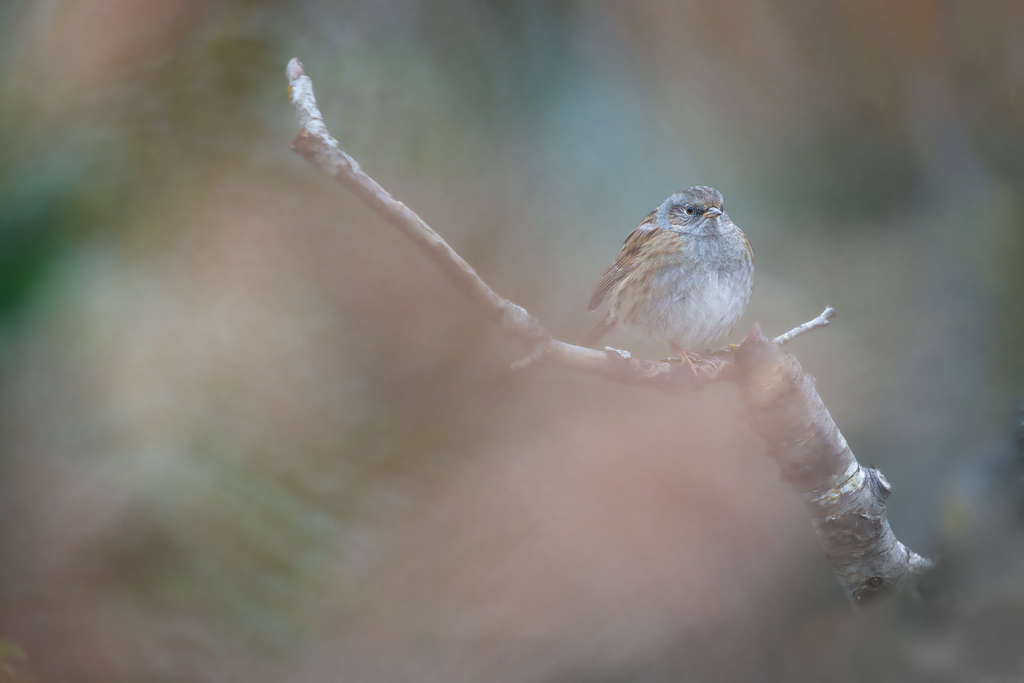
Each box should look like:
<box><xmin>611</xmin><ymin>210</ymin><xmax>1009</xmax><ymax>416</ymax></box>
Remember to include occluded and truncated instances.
<box><xmin>582</xmin><ymin>185</ymin><xmax>754</xmax><ymax>361</ymax></box>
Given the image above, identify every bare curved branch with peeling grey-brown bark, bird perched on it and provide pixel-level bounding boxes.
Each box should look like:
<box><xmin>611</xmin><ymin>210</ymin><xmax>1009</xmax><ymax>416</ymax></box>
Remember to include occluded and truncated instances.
<box><xmin>287</xmin><ymin>59</ymin><xmax>932</xmax><ymax>601</ymax></box>
